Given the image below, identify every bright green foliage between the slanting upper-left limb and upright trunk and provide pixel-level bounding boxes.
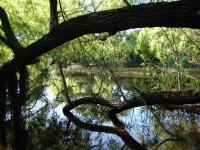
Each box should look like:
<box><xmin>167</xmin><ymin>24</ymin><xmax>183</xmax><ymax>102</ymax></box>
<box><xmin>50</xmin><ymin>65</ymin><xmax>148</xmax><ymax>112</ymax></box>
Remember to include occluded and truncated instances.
<box><xmin>0</xmin><ymin>0</ymin><xmax>49</xmax><ymax>46</ymax></box>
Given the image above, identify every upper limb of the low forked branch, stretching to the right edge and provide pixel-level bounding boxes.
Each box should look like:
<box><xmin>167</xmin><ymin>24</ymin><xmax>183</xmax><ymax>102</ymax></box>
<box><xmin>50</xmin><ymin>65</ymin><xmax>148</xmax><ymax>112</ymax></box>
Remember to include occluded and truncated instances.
<box><xmin>63</xmin><ymin>90</ymin><xmax>200</xmax><ymax>114</ymax></box>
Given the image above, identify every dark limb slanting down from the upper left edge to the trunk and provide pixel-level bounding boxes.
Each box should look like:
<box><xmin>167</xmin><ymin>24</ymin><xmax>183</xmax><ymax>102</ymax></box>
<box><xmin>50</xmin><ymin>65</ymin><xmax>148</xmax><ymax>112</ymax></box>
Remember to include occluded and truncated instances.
<box><xmin>0</xmin><ymin>6</ymin><xmax>22</xmax><ymax>55</ymax></box>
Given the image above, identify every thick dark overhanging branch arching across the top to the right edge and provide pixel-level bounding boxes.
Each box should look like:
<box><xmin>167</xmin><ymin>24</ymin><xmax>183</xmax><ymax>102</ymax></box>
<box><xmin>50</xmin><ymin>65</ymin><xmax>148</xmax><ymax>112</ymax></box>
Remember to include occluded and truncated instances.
<box><xmin>13</xmin><ymin>1</ymin><xmax>200</xmax><ymax>65</ymax></box>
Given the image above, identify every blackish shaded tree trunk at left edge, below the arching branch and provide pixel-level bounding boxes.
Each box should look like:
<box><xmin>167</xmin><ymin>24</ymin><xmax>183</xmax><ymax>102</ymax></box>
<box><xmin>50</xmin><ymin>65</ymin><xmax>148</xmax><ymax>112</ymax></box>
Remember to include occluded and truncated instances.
<box><xmin>0</xmin><ymin>63</ymin><xmax>27</xmax><ymax>150</ymax></box>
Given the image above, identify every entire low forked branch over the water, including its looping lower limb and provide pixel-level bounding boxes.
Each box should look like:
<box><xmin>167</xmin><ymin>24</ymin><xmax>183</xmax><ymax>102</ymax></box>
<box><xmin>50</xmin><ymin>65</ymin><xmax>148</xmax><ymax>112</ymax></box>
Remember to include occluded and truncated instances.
<box><xmin>63</xmin><ymin>90</ymin><xmax>200</xmax><ymax>149</ymax></box>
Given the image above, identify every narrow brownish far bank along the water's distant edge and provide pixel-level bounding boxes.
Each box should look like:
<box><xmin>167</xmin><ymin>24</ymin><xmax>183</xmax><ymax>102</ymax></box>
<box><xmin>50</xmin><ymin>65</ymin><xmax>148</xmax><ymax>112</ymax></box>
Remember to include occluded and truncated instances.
<box><xmin>52</xmin><ymin>65</ymin><xmax>200</xmax><ymax>79</ymax></box>
